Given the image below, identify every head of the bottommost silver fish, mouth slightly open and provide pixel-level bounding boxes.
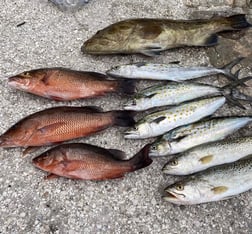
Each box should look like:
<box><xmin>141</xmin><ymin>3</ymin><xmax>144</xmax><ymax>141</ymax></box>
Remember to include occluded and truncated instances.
<box><xmin>163</xmin><ymin>176</ymin><xmax>213</xmax><ymax>205</ymax></box>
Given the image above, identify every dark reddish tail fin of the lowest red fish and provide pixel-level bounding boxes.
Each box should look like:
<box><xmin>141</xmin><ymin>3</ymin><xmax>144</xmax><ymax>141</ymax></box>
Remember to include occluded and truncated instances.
<box><xmin>129</xmin><ymin>144</ymin><xmax>152</xmax><ymax>171</ymax></box>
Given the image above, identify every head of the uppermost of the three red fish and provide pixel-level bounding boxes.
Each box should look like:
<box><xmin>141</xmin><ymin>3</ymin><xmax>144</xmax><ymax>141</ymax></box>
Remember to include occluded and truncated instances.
<box><xmin>8</xmin><ymin>69</ymin><xmax>46</xmax><ymax>91</ymax></box>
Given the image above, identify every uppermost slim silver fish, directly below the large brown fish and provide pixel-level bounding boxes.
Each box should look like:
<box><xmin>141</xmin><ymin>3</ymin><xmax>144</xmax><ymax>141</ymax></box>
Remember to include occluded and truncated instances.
<box><xmin>106</xmin><ymin>57</ymin><xmax>244</xmax><ymax>82</ymax></box>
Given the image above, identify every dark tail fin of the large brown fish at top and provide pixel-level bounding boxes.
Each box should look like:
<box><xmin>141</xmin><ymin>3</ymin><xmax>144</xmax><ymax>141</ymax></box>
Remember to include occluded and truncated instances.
<box><xmin>222</xmin><ymin>14</ymin><xmax>252</xmax><ymax>30</ymax></box>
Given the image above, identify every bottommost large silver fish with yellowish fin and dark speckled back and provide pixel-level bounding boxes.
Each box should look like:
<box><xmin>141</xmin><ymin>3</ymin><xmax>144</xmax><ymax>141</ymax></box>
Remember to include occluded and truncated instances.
<box><xmin>163</xmin><ymin>158</ymin><xmax>252</xmax><ymax>205</ymax></box>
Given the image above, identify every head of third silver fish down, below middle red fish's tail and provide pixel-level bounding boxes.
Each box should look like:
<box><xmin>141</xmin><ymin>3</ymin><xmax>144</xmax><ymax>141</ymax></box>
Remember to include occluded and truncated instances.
<box><xmin>124</xmin><ymin>121</ymin><xmax>151</xmax><ymax>139</ymax></box>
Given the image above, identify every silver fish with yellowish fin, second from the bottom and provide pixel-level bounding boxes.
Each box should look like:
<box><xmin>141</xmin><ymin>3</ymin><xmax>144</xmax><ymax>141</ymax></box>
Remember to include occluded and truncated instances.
<box><xmin>162</xmin><ymin>137</ymin><xmax>252</xmax><ymax>175</ymax></box>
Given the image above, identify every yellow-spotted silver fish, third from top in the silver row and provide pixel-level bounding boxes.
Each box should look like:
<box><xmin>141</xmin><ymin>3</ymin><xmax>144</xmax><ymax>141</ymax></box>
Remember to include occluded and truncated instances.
<box><xmin>124</xmin><ymin>97</ymin><xmax>226</xmax><ymax>139</ymax></box>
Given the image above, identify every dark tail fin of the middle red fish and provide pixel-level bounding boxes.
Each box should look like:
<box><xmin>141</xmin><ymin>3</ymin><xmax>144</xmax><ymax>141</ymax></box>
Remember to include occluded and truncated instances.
<box><xmin>113</xmin><ymin>111</ymin><xmax>136</xmax><ymax>127</ymax></box>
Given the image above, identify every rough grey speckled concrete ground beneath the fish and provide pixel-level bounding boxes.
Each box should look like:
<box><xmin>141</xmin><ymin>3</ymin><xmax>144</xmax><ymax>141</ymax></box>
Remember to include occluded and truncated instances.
<box><xmin>0</xmin><ymin>0</ymin><xmax>252</xmax><ymax>234</ymax></box>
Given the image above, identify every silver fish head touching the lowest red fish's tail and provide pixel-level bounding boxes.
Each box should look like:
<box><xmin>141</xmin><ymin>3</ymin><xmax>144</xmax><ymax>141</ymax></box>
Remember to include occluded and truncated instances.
<box><xmin>149</xmin><ymin>138</ymin><xmax>171</xmax><ymax>157</ymax></box>
